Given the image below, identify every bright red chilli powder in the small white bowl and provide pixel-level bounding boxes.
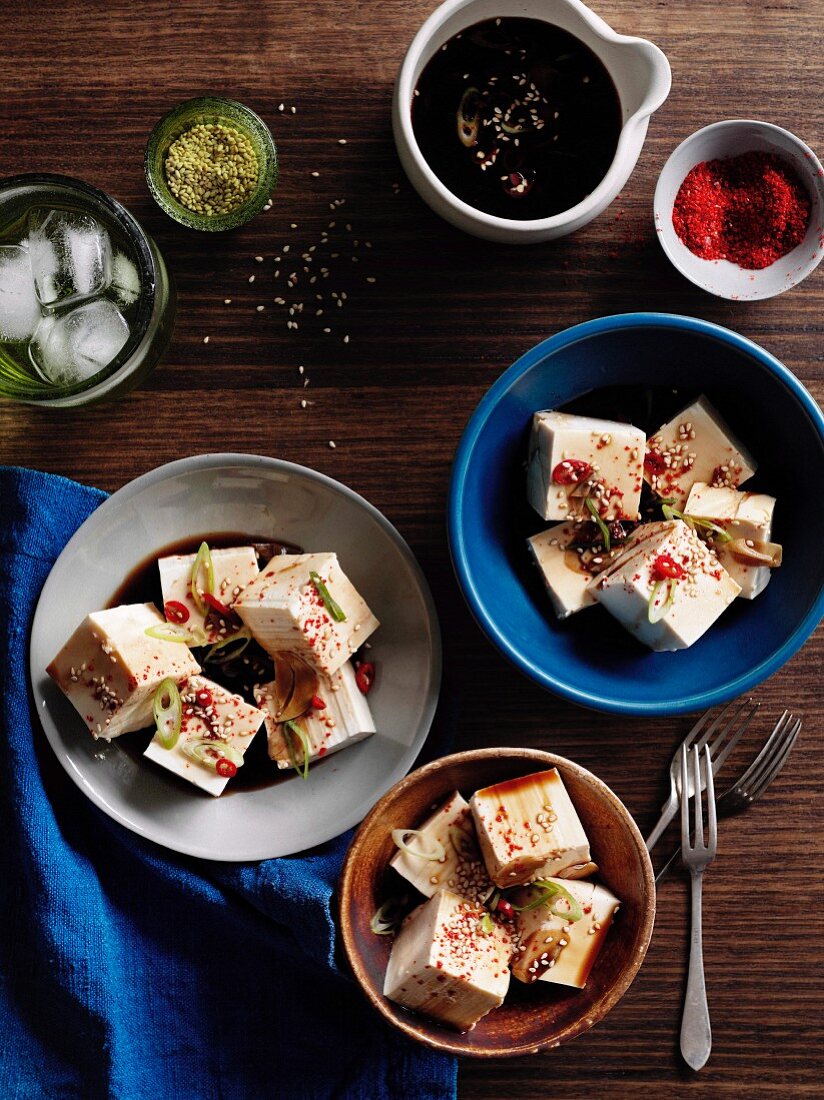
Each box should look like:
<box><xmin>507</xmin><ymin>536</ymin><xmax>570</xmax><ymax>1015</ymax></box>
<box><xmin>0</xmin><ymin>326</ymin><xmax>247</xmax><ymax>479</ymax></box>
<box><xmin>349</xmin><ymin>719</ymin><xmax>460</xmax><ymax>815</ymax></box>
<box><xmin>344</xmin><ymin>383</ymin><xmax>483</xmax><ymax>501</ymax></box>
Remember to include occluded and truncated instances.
<box><xmin>672</xmin><ymin>153</ymin><xmax>811</xmax><ymax>271</ymax></box>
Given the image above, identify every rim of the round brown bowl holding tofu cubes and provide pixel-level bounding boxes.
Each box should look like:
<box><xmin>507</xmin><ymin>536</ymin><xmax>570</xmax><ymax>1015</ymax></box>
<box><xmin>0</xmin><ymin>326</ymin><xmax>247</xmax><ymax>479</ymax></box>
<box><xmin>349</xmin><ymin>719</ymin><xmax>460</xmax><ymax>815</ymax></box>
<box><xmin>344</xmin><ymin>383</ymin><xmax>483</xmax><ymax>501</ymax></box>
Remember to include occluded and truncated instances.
<box><xmin>337</xmin><ymin>747</ymin><xmax>656</xmax><ymax>1058</ymax></box>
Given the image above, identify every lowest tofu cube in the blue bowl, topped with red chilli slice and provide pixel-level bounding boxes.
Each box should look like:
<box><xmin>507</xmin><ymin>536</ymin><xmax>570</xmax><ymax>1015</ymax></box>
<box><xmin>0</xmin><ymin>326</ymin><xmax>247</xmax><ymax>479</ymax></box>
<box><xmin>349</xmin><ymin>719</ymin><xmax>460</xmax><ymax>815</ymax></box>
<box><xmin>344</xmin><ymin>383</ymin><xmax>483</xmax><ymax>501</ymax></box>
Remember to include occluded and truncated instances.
<box><xmin>590</xmin><ymin>519</ymin><xmax>740</xmax><ymax>651</ymax></box>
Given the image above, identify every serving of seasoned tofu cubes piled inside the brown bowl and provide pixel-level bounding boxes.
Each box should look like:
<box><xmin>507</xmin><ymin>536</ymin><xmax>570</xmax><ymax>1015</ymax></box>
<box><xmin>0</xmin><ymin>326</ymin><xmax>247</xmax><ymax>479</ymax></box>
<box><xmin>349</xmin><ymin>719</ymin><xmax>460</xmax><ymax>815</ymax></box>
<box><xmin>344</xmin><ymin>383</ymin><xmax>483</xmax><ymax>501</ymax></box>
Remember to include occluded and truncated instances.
<box><xmin>372</xmin><ymin>768</ymin><xmax>619</xmax><ymax>1032</ymax></box>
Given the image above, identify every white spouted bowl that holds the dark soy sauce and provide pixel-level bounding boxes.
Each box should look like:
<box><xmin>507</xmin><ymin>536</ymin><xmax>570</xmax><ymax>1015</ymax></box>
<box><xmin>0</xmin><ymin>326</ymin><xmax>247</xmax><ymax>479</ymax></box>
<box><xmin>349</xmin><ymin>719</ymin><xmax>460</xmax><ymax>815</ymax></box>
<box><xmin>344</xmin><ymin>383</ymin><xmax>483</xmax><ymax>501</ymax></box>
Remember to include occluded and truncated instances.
<box><xmin>392</xmin><ymin>0</ymin><xmax>672</xmax><ymax>244</ymax></box>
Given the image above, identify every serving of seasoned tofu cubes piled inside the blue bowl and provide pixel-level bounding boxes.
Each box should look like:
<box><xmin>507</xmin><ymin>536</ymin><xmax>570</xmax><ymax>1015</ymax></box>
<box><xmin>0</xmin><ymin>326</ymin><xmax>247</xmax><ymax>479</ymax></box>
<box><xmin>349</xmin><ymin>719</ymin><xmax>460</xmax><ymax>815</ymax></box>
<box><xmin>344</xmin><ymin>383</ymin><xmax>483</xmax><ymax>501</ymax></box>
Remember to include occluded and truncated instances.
<box><xmin>527</xmin><ymin>395</ymin><xmax>782</xmax><ymax>650</ymax></box>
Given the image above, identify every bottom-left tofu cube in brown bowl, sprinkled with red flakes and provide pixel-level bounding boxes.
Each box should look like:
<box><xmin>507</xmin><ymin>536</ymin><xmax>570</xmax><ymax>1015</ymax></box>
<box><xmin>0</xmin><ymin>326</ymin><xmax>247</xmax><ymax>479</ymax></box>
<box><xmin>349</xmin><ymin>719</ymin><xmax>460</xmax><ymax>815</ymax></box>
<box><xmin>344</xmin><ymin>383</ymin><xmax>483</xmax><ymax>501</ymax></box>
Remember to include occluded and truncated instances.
<box><xmin>383</xmin><ymin>890</ymin><xmax>513</xmax><ymax>1032</ymax></box>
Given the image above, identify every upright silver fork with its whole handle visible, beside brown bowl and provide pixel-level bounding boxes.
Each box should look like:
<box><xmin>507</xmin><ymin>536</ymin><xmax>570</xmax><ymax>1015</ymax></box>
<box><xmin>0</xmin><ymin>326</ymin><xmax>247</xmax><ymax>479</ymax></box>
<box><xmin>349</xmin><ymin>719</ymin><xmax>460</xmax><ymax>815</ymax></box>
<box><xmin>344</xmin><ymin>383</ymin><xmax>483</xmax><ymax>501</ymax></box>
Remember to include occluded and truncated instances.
<box><xmin>681</xmin><ymin>745</ymin><xmax>718</xmax><ymax>1069</ymax></box>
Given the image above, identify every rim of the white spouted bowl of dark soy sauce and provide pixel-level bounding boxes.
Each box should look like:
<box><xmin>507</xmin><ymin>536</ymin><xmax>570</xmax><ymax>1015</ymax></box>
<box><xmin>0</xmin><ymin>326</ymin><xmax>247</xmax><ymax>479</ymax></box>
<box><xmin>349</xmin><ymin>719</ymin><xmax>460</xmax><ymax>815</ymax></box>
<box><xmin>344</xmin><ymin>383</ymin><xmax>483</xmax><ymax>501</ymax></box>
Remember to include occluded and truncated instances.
<box><xmin>393</xmin><ymin>0</ymin><xmax>672</xmax><ymax>238</ymax></box>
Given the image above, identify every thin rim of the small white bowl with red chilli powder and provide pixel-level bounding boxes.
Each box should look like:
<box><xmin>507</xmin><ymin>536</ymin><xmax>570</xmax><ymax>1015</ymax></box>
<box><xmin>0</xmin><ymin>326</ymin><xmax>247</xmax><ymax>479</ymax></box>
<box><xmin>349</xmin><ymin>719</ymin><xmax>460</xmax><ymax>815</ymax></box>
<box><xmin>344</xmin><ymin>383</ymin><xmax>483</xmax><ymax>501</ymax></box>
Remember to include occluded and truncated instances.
<box><xmin>652</xmin><ymin>119</ymin><xmax>824</xmax><ymax>303</ymax></box>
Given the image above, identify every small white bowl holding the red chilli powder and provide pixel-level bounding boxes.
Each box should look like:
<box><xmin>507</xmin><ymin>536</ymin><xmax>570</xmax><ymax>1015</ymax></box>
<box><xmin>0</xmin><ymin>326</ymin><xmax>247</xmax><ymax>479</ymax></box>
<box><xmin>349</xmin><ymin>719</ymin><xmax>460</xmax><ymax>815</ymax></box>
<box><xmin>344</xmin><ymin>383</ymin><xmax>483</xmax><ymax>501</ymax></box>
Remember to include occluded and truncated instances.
<box><xmin>653</xmin><ymin>119</ymin><xmax>824</xmax><ymax>301</ymax></box>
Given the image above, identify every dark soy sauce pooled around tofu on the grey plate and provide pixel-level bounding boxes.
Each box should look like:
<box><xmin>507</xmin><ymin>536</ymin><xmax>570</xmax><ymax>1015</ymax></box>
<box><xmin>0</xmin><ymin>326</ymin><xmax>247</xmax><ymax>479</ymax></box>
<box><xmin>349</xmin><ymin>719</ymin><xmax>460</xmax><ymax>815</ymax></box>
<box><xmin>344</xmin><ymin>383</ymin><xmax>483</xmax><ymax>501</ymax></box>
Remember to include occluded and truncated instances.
<box><xmin>107</xmin><ymin>531</ymin><xmax>305</xmax><ymax>799</ymax></box>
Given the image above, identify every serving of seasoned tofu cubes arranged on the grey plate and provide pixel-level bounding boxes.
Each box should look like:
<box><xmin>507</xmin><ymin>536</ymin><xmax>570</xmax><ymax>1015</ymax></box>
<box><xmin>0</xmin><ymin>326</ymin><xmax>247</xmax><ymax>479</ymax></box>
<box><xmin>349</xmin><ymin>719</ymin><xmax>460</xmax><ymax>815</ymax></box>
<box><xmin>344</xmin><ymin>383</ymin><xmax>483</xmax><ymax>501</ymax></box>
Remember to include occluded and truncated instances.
<box><xmin>46</xmin><ymin>542</ymin><xmax>378</xmax><ymax>795</ymax></box>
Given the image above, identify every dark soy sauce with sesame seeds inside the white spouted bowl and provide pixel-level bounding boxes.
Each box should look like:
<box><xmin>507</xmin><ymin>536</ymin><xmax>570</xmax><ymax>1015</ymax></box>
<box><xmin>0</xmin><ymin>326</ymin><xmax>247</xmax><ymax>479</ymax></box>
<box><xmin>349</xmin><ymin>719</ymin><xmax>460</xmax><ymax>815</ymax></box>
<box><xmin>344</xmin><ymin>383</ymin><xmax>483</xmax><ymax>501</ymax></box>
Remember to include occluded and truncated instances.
<box><xmin>411</xmin><ymin>18</ymin><xmax>622</xmax><ymax>221</ymax></box>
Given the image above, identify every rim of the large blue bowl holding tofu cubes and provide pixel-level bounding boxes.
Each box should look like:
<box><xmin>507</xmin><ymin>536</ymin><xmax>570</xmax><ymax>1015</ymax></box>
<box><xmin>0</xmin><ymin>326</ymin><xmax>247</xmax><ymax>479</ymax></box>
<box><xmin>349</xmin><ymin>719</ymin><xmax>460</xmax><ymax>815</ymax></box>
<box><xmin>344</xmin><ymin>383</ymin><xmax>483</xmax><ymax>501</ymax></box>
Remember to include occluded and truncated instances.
<box><xmin>447</xmin><ymin>312</ymin><xmax>824</xmax><ymax>716</ymax></box>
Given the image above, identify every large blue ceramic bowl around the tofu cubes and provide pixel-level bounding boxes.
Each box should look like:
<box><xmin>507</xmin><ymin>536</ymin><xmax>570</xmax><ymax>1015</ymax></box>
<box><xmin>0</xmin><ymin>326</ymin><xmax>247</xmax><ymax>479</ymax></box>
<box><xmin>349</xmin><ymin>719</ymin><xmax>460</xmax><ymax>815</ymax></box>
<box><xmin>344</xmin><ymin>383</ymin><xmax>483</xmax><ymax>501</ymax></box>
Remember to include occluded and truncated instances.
<box><xmin>449</xmin><ymin>314</ymin><xmax>824</xmax><ymax>714</ymax></box>
